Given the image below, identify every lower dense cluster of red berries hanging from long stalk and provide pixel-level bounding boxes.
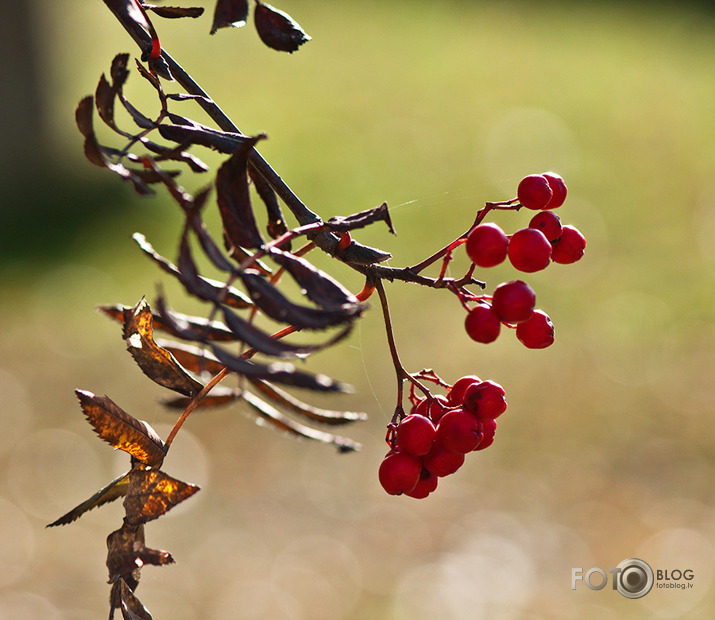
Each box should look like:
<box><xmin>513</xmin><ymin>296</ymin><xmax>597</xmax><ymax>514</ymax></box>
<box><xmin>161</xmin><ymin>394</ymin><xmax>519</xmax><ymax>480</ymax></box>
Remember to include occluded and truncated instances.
<box><xmin>378</xmin><ymin>375</ymin><xmax>507</xmax><ymax>499</ymax></box>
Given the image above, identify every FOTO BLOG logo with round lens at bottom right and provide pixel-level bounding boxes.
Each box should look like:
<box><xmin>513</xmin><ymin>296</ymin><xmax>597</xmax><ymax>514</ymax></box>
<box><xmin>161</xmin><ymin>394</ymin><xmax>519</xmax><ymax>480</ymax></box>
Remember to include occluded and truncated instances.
<box><xmin>571</xmin><ymin>558</ymin><xmax>695</xmax><ymax>599</ymax></box>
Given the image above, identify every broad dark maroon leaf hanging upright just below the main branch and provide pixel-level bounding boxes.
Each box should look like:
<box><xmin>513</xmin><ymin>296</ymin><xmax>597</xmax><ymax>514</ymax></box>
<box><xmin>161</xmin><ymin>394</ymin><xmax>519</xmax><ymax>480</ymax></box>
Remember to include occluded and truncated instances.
<box><xmin>216</xmin><ymin>136</ymin><xmax>263</xmax><ymax>248</ymax></box>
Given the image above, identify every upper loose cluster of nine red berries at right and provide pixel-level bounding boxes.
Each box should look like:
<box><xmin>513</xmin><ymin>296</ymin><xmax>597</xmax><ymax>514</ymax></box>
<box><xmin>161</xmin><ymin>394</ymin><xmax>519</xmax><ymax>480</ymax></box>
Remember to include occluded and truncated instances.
<box><xmin>465</xmin><ymin>172</ymin><xmax>586</xmax><ymax>349</ymax></box>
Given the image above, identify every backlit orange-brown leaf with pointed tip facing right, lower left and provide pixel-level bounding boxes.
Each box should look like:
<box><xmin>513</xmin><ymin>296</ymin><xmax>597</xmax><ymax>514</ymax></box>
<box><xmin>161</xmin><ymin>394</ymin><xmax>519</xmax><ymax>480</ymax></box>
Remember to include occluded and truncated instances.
<box><xmin>124</xmin><ymin>468</ymin><xmax>199</xmax><ymax>525</ymax></box>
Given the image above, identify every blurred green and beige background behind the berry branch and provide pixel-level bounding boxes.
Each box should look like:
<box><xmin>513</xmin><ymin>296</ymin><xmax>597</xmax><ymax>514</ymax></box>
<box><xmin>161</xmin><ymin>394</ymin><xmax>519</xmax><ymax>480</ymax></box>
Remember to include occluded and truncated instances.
<box><xmin>0</xmin><ymin>0</ymin><xmax>715</xmax><ymax>620</ymax></box>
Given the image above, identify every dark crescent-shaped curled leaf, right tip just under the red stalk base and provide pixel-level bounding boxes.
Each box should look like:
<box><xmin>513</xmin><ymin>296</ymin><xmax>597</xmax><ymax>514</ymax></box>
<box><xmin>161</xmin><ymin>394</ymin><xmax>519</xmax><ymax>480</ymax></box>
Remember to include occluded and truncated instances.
<box><xmin>241</xmin><ymin>269</ymin><xmax>364</xmax><ymax>329</ymax></box>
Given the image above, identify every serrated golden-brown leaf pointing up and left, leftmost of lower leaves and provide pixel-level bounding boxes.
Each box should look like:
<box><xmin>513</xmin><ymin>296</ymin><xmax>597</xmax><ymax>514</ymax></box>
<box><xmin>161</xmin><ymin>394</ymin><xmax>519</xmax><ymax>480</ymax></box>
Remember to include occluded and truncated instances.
<box><xmin>75</xmin><ymin>390</ymin><xmax>167</xmax><ymax>467</ymax></box>
